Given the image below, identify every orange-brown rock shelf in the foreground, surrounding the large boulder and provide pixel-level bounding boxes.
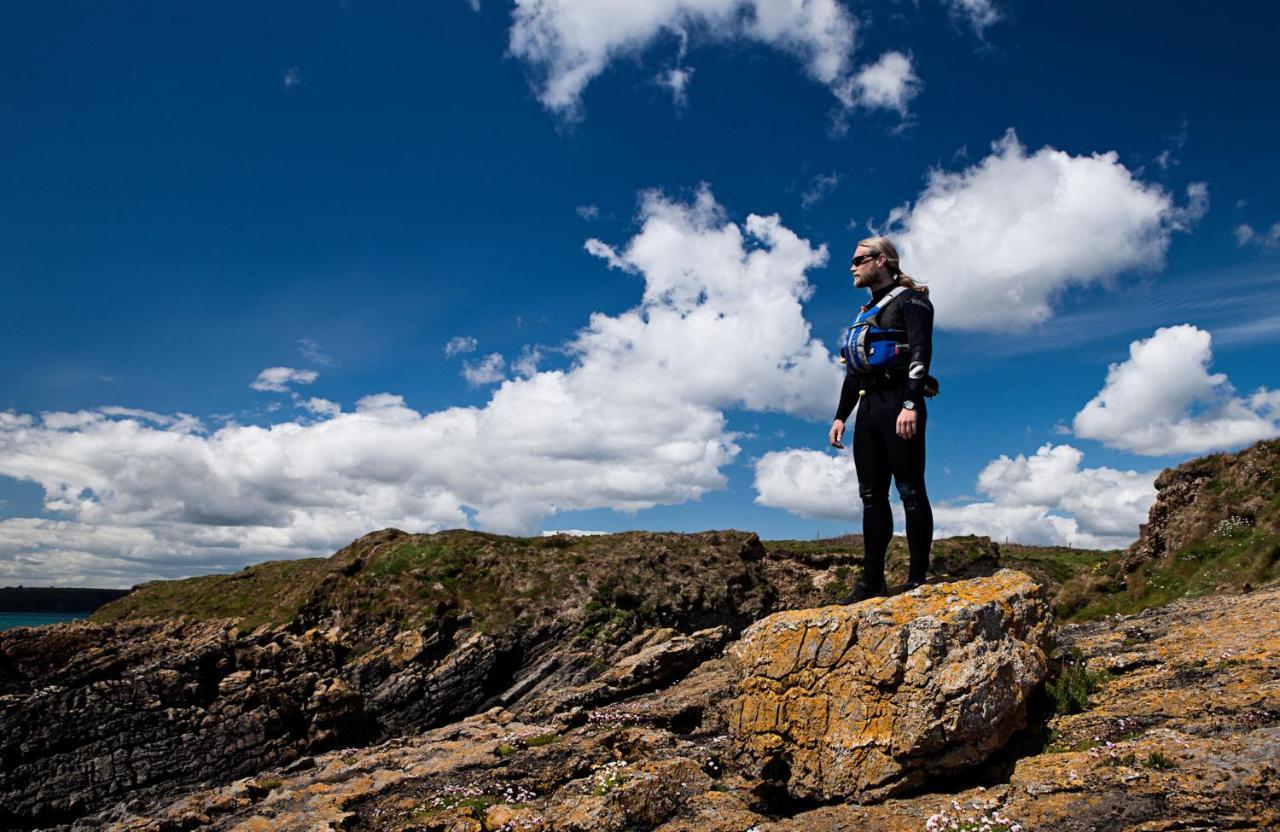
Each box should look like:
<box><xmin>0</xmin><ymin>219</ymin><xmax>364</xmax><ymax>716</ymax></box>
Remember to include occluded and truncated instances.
<box><xmin>94</xmin><ymin>570</ymin><xmax>1280</xmax><ymax>832</ymax></box>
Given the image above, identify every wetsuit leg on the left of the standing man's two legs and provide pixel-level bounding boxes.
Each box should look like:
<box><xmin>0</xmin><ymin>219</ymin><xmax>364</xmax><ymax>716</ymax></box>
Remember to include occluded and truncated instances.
<box><xmin>854</xmin><ymin>392</ymin><xmax>893</xmax><ymax>588</ymax></box>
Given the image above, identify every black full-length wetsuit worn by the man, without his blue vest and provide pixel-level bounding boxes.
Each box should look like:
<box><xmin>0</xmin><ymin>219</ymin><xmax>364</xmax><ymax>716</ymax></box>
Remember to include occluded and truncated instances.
<box><xmin>836</xmin><ymin>284</ymin><xmax>933</xmax><ymax>589</ymax></box>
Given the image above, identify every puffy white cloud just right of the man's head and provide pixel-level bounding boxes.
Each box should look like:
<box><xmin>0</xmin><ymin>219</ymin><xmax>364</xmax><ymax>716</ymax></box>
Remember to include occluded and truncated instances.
<box><xmin>886</xmin><ymin>129</ymin><xmax>1208</xmax><ymax>330</ymax></box>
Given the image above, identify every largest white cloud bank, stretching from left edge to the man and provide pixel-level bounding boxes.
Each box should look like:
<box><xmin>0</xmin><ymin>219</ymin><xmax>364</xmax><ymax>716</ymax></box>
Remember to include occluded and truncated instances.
<box><xmin>0</xmin><ymin>188</ymin><xmax>840</xmax><ymax>585</ymax></box>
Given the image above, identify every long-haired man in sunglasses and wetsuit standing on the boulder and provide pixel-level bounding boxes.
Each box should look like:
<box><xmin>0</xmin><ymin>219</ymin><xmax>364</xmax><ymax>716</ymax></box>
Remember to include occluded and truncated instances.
<box><xmin>827</xmin><ymin>237</ymin><xmax>937</xmax><ymax>604</ymax></box>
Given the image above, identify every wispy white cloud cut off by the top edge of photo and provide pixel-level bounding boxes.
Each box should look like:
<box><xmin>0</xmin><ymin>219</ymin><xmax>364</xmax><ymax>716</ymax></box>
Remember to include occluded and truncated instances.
<box><xmin>508</xmin><ymin>0</ymin><xmax>909</xmax><ymax>118</ymax></box>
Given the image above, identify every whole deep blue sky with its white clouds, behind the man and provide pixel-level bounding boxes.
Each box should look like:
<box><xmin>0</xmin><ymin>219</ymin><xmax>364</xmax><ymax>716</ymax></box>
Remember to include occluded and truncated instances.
<box><xmin>0</xmin><ymin>0</ymin><xmax>1280</xmax><ymax>586</ymax></box>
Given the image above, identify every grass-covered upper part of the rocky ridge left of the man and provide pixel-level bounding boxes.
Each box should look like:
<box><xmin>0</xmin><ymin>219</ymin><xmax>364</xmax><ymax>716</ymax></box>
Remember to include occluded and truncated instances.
<box><xmin>92</xmin><ymin>529</ymin><xmax>772</xmax><ymax>639</ymax></box>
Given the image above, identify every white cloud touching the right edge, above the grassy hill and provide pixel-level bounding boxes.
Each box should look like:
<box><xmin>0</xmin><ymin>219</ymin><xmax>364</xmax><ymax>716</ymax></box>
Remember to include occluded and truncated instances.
<box><xmin>1074</xmin><ymin>324</ymin><xmax>1280</xmax><ymax>456</ymax></box>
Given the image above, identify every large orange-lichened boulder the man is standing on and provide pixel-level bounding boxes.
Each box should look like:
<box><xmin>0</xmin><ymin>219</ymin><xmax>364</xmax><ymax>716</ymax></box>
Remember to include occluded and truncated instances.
<box><xmin>727</xmin><ymin>570</ymin><xmax>1053</xmax><ymax>800</ymax></box>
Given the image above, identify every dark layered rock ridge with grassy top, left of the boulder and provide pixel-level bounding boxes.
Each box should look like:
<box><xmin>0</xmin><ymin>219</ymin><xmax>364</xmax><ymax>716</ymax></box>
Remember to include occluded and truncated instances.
<box><xmin>0</xmin><ymin>530</ymin><xmax>773</xmax><ymax>828</ymax></box>
